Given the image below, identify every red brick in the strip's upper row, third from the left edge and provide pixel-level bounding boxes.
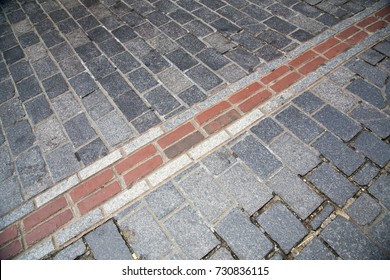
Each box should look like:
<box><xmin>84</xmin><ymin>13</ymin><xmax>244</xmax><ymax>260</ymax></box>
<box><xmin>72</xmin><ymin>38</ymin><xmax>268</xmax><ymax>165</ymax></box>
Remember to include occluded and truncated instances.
<box><xmin>69</xmin><ymin>169</ymin><xmax>114</xmax><ymax>202</ymax></box>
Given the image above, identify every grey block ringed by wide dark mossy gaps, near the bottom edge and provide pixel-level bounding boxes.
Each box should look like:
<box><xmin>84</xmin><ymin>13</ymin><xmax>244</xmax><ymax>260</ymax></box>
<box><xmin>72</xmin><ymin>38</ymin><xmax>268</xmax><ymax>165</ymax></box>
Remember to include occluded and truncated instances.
<box><xmin>256</xmin><ymin>201</ymin><xmax>308</xmax><ymax>254</ymax></box>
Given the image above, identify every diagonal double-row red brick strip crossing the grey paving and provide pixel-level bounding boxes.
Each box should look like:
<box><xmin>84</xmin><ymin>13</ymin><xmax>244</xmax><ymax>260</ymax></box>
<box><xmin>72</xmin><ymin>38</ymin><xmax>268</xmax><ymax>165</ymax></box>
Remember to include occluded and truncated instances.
<box><xmin>0</xmin><ymin>6</ymin><xmax>390</xmax><ymax>259</ymax></box>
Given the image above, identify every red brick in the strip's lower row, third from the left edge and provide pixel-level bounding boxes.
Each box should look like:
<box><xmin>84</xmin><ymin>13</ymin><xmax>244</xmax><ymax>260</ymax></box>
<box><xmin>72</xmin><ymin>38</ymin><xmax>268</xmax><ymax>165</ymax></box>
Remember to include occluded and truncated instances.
<box><xmin>77</xmin><ymin>182</ymin><xmax>121</xmax><ymax>215</ymax></box>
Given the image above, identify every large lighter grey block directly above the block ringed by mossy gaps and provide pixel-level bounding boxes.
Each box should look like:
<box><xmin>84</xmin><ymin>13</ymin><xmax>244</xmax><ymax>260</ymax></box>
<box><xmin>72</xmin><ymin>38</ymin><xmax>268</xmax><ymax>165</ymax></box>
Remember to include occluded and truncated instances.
<box><xmin>266</xmin><ymin>168</ymin><xmax>323</xmax><ymax>219</ymax></box>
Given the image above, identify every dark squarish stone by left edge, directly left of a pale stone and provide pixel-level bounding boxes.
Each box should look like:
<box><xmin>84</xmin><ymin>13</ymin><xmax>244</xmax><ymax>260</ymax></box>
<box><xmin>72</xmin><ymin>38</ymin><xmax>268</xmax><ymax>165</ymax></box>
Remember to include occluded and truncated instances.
<box><xmin>5</xmin><ymin>120</ymin><xmax>35</xmax><ymax>156</ymax></box>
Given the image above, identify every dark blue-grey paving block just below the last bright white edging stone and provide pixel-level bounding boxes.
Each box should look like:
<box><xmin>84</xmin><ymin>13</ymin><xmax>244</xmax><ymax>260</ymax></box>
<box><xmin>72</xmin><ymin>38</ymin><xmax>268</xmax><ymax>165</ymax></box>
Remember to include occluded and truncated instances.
<box><xmin>232</xmin><ymin>136</ymin><xmax>282</xmax><ymax>180</ymax></box>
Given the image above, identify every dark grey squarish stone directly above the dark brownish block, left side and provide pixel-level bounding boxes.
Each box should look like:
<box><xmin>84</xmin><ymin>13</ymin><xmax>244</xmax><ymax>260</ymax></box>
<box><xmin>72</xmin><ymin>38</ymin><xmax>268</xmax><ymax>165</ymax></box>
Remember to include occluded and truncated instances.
<box><xmin>64</xmin><ymin>113</ymin><xmax>96</xmax><ymax>147</ymax></box>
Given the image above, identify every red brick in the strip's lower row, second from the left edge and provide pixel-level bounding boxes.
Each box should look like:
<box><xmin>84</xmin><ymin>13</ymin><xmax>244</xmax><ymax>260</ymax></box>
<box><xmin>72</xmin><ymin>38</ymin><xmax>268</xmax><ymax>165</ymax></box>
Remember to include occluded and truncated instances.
<box><xmin>25</xmin><ymin>209</ymin><xmax>73</xmax><ymax>246</ymax></box>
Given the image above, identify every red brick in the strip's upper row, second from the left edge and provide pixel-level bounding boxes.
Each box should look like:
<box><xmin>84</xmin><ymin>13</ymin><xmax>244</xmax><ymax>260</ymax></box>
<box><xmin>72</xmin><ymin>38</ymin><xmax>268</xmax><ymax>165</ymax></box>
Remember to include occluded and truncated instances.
<box><xmin>23</xmin><ymin>196</ymin><xmax>68</xmax><ymax>230</ymax></box>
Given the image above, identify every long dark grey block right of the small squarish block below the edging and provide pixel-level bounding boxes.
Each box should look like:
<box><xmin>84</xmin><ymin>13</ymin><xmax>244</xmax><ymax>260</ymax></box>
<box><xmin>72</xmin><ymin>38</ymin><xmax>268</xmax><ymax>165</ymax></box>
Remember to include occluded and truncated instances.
<box><xmin>276</xmin><ymin>106</ymin><xmax>323</xmax><ymax>143</ymax></box>
